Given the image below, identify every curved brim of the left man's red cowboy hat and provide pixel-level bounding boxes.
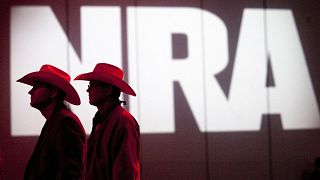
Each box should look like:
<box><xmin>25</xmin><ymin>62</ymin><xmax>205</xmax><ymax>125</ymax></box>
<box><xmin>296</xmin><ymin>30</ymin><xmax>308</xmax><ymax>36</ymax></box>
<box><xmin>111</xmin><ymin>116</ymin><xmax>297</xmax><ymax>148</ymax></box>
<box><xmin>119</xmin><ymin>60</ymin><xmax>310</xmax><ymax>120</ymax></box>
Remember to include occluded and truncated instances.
<box><xmin>17</xmin><ymin>72</ymin><xmax>81</xmax><ymax>105</ymax></box>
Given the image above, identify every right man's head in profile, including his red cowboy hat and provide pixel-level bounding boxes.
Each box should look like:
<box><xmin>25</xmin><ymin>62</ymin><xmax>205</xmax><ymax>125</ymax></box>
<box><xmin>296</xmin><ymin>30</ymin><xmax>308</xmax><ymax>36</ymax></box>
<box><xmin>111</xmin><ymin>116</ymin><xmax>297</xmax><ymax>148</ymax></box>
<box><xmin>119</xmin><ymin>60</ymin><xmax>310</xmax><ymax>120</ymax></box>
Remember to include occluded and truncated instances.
<box><xmin>75</xmin><ymin>63</ymin><xmax>136</xmax><ymax>106</ymax></box>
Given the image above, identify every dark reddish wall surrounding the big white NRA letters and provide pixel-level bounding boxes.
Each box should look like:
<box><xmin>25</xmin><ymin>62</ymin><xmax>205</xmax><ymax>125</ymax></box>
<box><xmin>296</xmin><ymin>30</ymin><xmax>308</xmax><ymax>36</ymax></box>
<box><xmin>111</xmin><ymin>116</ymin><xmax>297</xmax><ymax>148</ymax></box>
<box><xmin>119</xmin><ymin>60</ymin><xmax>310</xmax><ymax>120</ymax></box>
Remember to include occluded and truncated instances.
<box><xmin>0</xmin><ymin>0</ymin><xmax>320</xmax><ymax>180</ymax></box>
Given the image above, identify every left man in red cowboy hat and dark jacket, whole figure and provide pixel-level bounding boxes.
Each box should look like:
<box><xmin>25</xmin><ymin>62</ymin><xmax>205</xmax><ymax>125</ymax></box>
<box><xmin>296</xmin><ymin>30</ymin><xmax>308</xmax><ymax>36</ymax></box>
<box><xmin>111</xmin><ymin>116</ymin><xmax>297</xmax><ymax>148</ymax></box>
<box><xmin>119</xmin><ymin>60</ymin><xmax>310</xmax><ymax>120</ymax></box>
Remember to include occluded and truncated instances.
<box><xmin>17</xmin><ymin>65</ymin><xmax>86</xmax><ymax>180</ymax></box>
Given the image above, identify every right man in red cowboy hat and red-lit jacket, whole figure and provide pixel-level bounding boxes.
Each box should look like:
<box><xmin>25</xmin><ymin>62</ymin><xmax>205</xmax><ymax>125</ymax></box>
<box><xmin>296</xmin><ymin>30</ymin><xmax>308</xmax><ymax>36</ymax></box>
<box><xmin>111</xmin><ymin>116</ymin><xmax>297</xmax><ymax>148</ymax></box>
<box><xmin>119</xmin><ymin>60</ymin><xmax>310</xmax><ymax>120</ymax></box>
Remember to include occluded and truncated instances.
<box><xmin>75</xmin><ymin>63</ymin><xmax>140</xmax><ymax>180</ymax></box>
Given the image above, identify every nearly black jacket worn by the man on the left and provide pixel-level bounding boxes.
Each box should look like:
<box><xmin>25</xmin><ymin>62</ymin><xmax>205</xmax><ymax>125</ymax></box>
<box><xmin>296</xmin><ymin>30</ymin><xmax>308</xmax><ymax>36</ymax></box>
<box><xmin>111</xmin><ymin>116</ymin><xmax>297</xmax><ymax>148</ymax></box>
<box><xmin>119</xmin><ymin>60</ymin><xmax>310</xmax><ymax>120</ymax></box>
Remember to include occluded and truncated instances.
<box><xmin>24</xmin><ymin>105</ymin><xmax>86</xmax><ymax>180</ymax></box>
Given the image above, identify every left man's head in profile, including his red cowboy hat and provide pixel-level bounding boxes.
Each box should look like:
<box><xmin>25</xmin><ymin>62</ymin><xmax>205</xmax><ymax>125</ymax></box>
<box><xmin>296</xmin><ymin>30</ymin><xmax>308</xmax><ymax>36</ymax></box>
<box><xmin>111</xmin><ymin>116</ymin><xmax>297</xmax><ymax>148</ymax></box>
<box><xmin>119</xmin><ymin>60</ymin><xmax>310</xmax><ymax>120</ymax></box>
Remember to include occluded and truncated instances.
<box><xmin>17</xmin><ymin>65</ymin><xmax>80</xmax><ymax>109</ymax></box>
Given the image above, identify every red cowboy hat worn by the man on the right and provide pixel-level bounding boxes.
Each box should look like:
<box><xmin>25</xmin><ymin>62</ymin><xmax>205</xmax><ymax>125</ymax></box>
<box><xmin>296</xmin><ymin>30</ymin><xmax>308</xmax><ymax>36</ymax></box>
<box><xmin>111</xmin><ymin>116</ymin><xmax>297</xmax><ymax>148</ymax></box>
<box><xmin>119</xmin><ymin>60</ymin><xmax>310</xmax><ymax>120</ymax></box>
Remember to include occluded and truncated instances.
<box><xmin>75</xmin><ymin>63</ymin><xmax>136</xmax><ymax>96</ymax></box>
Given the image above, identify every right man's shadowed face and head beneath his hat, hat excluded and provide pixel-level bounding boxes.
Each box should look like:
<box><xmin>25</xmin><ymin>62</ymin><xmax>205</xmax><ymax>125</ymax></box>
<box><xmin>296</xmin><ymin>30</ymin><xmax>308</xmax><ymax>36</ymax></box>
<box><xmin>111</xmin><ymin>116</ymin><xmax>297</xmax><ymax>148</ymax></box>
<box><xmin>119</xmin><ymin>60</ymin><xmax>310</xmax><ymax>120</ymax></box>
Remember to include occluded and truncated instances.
<box><xmin>87</xmin><ymin>81</ymin><xmax>121</xmax><ymax>106</ymax></box>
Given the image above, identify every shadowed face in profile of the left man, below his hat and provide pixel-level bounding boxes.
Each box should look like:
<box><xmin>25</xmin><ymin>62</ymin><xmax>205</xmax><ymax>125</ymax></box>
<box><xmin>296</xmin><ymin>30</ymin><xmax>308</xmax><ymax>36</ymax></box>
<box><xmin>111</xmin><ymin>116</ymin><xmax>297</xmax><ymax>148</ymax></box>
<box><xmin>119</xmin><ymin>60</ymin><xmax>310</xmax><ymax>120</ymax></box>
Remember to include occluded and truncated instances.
<box><xmin>29</xmin><ymin>82</ymin><xmax>52</xmax><ymax>109</ymax></box>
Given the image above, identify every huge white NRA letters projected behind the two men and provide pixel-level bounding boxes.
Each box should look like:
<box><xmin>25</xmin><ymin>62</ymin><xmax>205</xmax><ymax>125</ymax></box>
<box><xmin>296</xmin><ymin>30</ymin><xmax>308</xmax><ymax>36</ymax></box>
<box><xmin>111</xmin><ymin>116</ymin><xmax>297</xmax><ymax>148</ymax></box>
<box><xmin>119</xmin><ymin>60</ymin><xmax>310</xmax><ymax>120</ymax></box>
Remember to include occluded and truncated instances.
<box><xmin>10</xmin><ymin>6</ymin><xmax>320</xmax><ymax>136</ymax></box>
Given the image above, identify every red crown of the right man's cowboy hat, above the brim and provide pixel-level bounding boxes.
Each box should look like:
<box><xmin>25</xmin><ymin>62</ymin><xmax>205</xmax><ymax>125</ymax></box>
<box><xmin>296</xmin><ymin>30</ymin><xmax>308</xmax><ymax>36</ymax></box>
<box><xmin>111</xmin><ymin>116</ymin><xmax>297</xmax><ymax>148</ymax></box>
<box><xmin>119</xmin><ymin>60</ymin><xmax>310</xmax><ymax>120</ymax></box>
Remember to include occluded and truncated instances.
<box><xmin>93</xmin><ymin>63</ymin><xmax>124</xmax><ymax>80</ymax></box>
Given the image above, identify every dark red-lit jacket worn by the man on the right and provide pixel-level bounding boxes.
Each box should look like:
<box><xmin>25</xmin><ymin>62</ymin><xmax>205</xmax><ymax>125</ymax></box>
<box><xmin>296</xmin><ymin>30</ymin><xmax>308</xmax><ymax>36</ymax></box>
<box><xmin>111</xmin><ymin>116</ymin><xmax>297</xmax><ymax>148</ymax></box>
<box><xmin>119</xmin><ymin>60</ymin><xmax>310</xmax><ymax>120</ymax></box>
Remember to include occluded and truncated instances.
<box><xmin>86</xmin><ymin>105</ymin><xmax>140</xmax><ymax>180</ymax></box>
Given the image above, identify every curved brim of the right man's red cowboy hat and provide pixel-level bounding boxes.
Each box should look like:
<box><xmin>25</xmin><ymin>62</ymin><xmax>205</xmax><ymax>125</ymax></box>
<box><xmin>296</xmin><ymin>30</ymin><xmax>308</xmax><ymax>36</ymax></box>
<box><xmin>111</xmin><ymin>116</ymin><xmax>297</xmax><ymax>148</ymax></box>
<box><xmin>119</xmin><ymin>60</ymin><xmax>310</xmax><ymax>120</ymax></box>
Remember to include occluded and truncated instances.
<box><xmin>74</xmin><ymin>72</ymin><xmax>136</xmax><ymax>96</ymax></box>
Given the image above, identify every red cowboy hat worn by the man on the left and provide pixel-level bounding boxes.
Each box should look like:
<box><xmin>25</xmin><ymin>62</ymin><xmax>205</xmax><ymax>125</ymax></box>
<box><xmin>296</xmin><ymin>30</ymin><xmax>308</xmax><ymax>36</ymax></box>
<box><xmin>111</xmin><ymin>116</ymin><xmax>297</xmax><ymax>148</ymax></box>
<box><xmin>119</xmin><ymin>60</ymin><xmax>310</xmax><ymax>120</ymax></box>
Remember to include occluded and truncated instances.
<box><xmin>17</xmin><ymin>64</ymin><xmax>81</xmax><ymax>105</ymax></box>
